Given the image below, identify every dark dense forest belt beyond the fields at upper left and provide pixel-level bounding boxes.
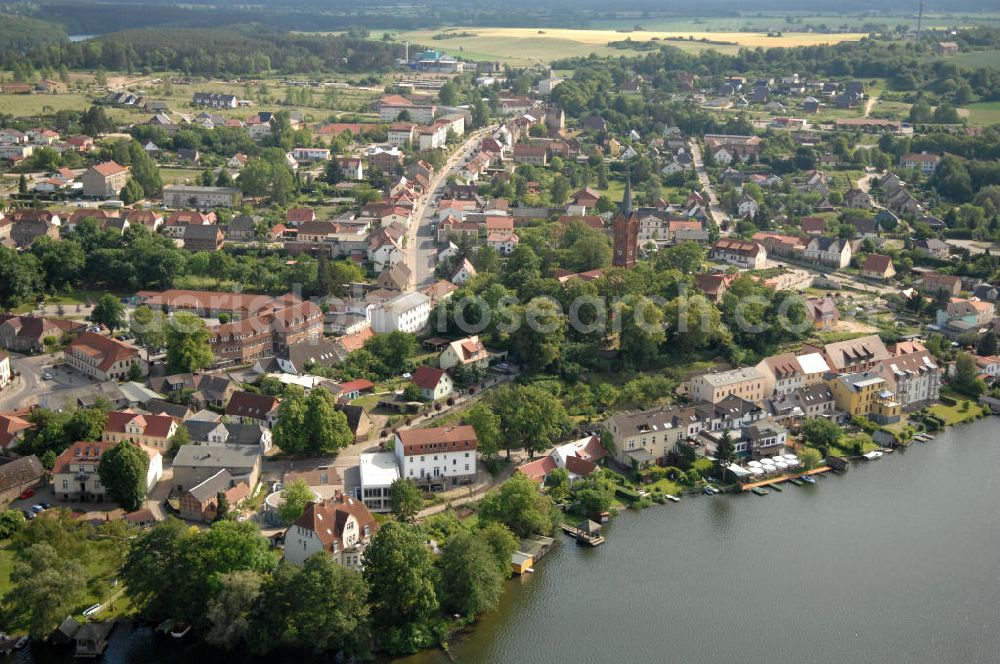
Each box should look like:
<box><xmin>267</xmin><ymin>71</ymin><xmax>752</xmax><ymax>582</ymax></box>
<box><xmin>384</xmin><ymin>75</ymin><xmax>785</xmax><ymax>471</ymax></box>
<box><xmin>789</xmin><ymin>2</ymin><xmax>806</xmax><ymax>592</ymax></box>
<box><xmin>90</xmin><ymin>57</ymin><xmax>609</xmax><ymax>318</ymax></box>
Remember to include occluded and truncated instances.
<box><xmin>0</xmin><ymin>26</ymin><xmax>403</xmax><ymax>76</ymax></box>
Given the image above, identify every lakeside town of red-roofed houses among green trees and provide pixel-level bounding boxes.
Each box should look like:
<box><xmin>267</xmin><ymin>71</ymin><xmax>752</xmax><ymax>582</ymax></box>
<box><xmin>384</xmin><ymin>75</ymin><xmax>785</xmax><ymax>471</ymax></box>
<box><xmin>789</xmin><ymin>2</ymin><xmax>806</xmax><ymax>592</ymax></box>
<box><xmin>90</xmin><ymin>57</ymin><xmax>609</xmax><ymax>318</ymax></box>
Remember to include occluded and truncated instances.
<box><xmin>0</xmin><ymin>14</ymin><xmax>1000</xmax><ymax>656</ymax></box>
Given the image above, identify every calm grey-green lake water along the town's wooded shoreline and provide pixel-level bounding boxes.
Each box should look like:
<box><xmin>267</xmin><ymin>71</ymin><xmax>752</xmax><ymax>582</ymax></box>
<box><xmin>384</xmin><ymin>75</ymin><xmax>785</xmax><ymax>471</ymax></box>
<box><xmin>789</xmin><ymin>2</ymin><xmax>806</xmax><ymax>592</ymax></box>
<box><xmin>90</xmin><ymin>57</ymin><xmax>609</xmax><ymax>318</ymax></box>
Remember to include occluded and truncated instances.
<box><xmin>9</xmin><ymin>418</ymin><xmax>1000</xmax><ymax>664</ymax></box>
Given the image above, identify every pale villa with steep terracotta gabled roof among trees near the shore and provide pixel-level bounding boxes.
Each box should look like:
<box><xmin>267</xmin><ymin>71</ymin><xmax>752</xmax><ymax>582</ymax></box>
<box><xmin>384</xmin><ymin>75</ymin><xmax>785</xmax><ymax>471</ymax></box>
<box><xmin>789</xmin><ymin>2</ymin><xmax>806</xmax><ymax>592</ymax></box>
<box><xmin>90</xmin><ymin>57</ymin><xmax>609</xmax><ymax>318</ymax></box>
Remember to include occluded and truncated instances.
<box><xmin>285</xmin><ymin>494</ymin><xmax>378</xmax><ymax>569</ymax></box>
